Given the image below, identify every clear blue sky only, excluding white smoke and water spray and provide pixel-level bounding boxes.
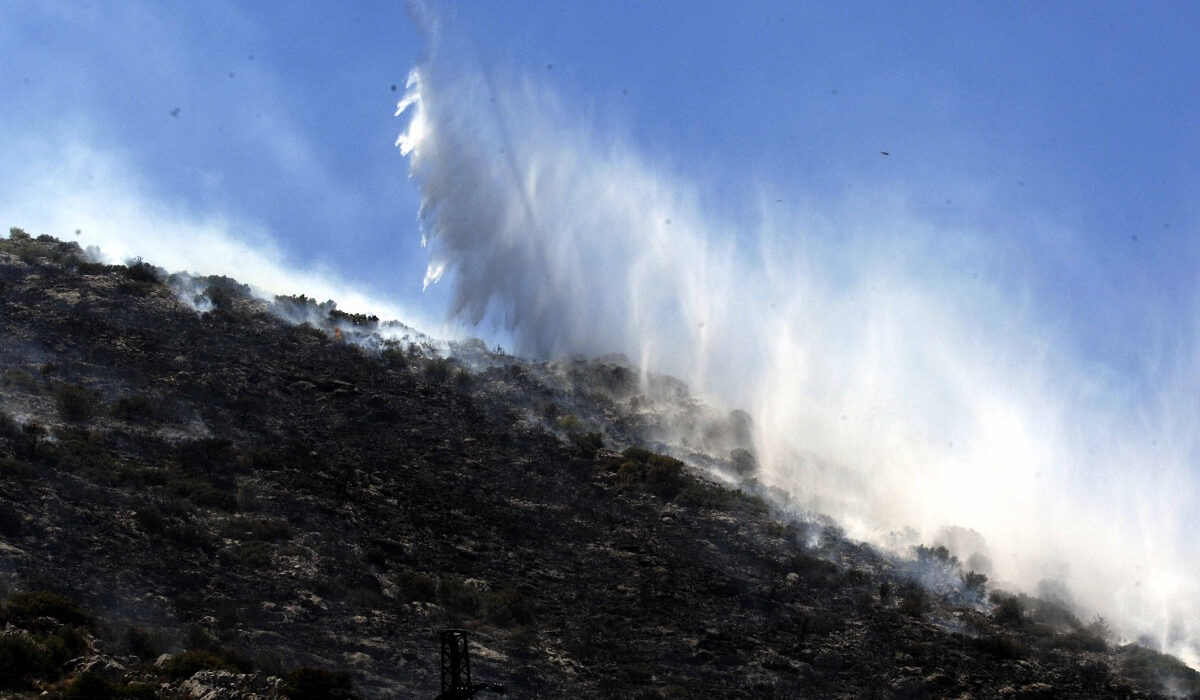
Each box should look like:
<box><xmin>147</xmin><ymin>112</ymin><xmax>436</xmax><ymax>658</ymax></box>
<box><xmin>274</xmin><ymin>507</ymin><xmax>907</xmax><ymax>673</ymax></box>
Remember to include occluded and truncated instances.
<box><xmin>0</xmin><ymin>1</ymin><xmax>1200</xmax><ymax>364</ymax></box>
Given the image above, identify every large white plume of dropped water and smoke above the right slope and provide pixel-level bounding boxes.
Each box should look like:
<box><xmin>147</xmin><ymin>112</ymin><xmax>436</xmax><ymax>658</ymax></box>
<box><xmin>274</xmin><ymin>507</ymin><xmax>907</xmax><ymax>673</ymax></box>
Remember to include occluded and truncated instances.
<box><xmin>398</xmin><ymin>45</ymin><xmax>1200</xmax><ymax>663</ymax></box>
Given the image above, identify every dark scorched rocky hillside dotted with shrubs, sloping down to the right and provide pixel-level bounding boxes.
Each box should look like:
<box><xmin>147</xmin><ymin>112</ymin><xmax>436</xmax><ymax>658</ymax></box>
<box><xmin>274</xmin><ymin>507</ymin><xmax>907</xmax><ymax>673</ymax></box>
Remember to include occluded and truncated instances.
<box><xmin>0</xmin><ymin>231</ymin><xmax>1200</xmax><ymax>699</ymax></box>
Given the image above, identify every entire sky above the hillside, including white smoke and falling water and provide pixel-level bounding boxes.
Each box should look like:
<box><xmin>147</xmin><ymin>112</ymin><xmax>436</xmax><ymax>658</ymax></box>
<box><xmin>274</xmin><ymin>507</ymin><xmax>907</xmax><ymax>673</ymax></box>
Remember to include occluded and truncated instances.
<box><xmin>7</xmin><ymin>0</ymin><xmax>1200</xmax><ymax>659</ymax></box>
